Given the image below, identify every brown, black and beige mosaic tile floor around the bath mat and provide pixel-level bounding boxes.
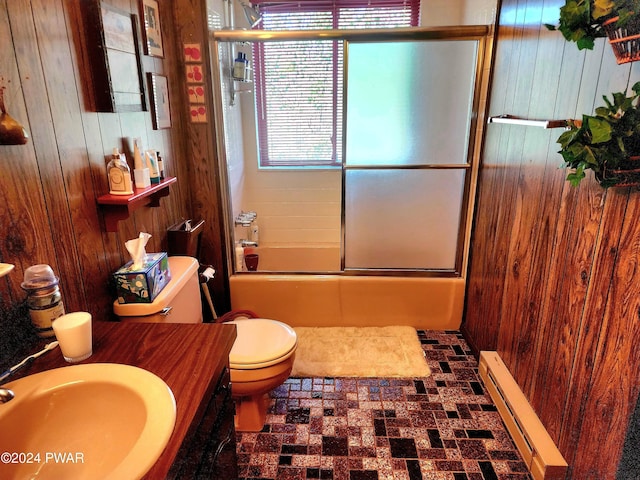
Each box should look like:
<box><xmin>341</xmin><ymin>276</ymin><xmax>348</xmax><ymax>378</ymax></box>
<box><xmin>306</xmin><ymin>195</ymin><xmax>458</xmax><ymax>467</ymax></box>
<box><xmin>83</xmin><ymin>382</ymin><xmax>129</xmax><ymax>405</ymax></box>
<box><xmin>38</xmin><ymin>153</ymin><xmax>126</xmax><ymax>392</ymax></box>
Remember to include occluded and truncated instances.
<box><xmin>238</xmin><ymin>330</ymin><xmax>531</xmax><ymax>480</ymax></box>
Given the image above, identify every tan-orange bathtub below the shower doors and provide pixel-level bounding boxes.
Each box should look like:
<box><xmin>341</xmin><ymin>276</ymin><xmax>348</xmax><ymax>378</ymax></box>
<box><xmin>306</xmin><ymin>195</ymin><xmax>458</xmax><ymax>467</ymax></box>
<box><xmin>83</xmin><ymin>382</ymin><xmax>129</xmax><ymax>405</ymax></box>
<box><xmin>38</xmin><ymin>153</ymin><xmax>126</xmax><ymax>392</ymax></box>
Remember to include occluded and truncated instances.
<box><xmin>229</xmin><ymin>258</ymin><xmax>465</xmax><ymax>330</ymax></box>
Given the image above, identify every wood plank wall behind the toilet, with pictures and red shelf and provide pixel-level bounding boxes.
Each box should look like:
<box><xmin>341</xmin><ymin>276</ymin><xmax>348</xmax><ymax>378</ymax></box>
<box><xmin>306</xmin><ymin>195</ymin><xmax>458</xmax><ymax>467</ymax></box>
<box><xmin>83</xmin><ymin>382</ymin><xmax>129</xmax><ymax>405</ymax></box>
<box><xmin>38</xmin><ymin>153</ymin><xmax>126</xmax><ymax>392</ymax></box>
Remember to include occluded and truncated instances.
<box><xmin>0</xmin><ymin>0</ymin><xmax>230</xmax><ymax>364</ymax></box>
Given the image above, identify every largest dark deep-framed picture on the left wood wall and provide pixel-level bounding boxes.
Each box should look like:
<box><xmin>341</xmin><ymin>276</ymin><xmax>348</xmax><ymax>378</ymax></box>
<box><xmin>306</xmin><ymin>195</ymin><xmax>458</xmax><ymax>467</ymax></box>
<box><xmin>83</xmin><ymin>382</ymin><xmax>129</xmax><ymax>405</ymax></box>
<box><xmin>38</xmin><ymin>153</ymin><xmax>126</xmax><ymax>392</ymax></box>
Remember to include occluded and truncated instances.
<box><xmin>82</xmin><ymin>0</ymin><xmax>147</xmax><ymax>112</ymax></box>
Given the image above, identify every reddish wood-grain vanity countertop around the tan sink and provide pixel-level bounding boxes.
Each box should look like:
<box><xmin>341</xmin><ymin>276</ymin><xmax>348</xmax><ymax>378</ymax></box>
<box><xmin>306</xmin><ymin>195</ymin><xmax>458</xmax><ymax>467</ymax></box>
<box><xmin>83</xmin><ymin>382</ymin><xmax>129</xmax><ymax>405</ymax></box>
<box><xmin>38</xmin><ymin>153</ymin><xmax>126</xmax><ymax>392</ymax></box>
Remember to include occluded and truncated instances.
<box><xmin>12</xmin><ymin>321</ymin><xmax>236</xmax><ymax>479</ymax></box>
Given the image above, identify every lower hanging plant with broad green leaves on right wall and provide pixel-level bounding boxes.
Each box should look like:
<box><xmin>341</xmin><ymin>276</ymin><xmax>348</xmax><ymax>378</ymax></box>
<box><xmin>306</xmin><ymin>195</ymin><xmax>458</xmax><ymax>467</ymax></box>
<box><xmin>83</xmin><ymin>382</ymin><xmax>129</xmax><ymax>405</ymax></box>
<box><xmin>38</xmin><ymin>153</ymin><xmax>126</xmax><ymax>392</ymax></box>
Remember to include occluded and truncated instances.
<box><xmin>557</xmin><ymin>82</ymin><xmax>640</xmax><ymax>188</ymax></box>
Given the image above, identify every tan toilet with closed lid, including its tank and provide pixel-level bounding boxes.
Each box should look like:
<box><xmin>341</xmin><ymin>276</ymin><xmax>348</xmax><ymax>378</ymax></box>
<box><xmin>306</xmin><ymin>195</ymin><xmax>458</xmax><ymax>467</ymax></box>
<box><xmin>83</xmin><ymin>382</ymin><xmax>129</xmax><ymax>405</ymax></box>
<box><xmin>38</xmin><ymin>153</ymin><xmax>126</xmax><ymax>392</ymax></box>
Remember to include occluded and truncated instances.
<box><xmin>113</xmin><ymin>256</ymin><xmax>298</xmax><ymax>432</ymax></box>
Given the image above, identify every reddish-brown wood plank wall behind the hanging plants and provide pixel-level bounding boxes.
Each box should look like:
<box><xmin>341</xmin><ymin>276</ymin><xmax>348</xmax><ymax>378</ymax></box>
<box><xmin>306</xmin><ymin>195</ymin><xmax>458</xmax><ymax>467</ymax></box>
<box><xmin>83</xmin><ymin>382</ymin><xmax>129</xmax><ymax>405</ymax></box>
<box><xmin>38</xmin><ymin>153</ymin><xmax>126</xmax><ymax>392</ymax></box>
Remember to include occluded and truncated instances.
<box><xmin>463</xmin><ymin>0</ymin><xmax>640</xmax><ymax>479</ymax></box>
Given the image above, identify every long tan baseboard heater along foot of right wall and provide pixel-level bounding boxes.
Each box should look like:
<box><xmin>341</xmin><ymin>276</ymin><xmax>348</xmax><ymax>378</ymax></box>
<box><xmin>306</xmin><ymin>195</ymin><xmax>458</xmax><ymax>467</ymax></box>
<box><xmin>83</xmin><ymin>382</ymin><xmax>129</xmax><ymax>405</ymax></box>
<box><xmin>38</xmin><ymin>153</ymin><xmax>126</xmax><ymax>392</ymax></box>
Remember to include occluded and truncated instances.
<box><xmin>480</xmin><ymin>351</ymin><xmax>567</xmax><ymax>480</ymax></box>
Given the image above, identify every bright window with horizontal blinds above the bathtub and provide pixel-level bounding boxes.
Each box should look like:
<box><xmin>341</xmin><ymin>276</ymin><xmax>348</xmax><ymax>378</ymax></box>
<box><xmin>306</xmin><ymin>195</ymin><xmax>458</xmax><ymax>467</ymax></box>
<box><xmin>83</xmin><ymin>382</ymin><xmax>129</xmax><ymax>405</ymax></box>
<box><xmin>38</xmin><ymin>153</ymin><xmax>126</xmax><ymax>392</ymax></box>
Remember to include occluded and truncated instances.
<box><xmin>253</xmin><ymin>0</ymin><xmax>419</xmax><ymax>167</ymax></box>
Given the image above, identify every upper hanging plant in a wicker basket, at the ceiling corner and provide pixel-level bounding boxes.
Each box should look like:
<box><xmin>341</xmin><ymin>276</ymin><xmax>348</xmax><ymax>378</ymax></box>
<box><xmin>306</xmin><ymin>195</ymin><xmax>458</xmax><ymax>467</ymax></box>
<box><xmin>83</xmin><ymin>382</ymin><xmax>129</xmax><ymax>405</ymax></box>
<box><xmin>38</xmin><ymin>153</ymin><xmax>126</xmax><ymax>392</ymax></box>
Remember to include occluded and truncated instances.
<box><xmin>545</xmin><ymin>0</ymin><xmax>640</xmax><ymax>63</ymax></box>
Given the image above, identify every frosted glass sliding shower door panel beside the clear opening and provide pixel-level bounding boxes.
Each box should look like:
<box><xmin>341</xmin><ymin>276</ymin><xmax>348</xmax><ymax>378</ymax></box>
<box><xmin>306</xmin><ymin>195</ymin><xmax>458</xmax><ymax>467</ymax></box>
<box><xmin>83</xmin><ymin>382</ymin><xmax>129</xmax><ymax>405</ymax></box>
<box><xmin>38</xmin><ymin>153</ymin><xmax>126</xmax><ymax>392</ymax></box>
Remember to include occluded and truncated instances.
<box><xmin>343</xmin><ymin>40</ymin><xmax>479</xmax><ymax>272</ymax></box>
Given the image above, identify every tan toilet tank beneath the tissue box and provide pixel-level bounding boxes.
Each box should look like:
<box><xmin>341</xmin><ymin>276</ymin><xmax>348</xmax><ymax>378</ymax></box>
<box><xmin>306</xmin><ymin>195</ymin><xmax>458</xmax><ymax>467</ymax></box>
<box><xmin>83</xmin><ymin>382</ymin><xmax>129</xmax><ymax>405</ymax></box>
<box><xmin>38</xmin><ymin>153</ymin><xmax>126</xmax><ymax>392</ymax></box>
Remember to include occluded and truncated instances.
<box><xmin>113</xmin><ymin>256</ymin><xmax>202</xmax><ymax>323</ymax></box>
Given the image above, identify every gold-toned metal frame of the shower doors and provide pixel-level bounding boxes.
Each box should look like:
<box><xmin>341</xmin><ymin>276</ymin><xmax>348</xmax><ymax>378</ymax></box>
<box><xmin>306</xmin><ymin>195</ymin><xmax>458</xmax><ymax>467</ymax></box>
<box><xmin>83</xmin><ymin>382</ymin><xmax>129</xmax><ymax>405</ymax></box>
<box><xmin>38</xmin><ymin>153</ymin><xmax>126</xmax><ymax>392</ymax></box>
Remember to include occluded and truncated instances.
<box><xmin>209</xmin><ymin>25</ymin><xmax>492</xmax><ymax>277</ymax></box>
